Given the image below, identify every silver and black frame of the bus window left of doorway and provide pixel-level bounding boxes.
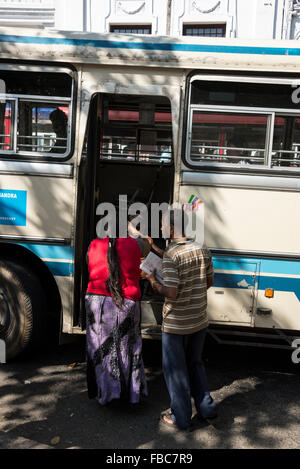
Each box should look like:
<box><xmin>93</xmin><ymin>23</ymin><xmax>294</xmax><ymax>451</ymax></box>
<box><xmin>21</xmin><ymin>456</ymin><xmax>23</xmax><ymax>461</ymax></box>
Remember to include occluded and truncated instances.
<box><xmin>0</xmin><ymin>60</ymin><xmax>78</xmax><ymax>163</ymax></box>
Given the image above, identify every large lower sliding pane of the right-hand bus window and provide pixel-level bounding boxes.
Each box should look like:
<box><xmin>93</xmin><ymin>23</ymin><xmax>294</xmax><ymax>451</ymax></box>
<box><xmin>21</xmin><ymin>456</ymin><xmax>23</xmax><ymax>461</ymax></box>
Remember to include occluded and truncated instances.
<box><xmin>190</xmin><ymin>111</ymin><xmax>268</xmax><ymax>165</ymax></box>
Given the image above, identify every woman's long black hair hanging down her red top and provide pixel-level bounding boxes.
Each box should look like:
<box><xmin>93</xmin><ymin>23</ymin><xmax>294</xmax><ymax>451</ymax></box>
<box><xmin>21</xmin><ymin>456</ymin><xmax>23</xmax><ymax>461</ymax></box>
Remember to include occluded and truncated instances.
<box><xmin>106</xmin><ymin>238</ymin><xmax>123</xmax><ymax>308</ymax></box>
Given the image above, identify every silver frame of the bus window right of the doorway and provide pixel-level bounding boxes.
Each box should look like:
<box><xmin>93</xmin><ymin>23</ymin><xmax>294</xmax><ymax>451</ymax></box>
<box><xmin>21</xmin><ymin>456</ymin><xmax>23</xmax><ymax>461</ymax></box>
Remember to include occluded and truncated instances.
<box><xmin>181</xmin><ymin>70</ymin><xmax>300</xmax><ymax>176</ymax></box>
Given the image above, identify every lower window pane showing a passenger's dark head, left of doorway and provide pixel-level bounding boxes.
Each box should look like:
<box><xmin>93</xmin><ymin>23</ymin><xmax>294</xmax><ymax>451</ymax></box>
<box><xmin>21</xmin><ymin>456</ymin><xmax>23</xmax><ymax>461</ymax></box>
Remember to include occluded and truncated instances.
<box><xmin>17</xmin><ymin>99</ymin><xmax>69</xmax><ymax>154</ymax></box>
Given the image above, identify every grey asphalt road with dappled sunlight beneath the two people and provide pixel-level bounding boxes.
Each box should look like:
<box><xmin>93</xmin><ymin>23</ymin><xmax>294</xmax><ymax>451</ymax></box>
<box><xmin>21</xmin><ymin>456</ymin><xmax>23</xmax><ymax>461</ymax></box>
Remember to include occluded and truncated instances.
<box><xmin>0</xmin><ymin>337</ymin><xmax>300</xmax><ymax>449</ymax></box>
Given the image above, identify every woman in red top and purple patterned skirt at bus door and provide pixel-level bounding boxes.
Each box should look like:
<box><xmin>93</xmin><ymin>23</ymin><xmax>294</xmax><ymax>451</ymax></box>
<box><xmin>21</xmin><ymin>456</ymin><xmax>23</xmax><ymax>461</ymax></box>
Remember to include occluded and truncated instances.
<box><xmin>85</xmin><ymin>231</ymin><xmax>147</xmax><ymax>405</ymax></box>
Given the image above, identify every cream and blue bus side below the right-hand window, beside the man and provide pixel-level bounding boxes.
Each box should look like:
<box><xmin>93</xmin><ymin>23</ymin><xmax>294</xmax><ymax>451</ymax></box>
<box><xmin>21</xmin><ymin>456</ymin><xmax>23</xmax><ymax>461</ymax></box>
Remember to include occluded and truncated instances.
<box><xmin>180</xmin><ymin>179</ymin><xmax>300</xmax><ymax>330</ymax></box>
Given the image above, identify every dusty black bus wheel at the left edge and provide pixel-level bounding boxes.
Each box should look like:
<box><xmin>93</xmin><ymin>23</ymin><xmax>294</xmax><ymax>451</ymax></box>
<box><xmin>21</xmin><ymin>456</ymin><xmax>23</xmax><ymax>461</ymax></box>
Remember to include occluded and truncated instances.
<box><xmin>0</xmin><ymin>260</ymin><xmax>46</xmax><ymax>361</ymax></box>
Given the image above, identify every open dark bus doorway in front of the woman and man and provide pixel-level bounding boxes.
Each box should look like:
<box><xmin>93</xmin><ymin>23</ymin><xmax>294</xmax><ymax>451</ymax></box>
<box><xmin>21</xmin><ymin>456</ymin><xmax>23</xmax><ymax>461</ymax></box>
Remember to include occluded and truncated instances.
<box><xmin>75</xmin><ymin>94</ymin><xmax>174</xmax><ymax>328</ymax></box>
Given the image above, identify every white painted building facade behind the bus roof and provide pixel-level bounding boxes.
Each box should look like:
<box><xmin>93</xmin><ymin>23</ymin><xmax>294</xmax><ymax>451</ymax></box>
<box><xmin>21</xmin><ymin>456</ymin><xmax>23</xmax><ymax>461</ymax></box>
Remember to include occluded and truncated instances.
<box><xmin>0</xmin><ymin>0</ymin><xmax>300</xmax><ymax>39</ymax></box>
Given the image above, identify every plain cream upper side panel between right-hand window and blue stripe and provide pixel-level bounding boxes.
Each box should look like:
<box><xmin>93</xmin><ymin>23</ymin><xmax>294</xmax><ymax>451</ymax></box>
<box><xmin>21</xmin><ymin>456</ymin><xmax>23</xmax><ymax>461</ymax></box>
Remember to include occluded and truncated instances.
<box><xmin>180</xmin><ymin>180</ymin><xmax>300</xmax><ymax>254</ymax></box>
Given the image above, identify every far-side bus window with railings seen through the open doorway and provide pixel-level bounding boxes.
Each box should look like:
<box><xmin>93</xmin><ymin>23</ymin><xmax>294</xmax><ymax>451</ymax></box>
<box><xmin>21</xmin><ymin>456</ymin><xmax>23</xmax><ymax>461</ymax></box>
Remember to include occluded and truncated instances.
<box><xmin>100</xmin><ymin>95</ymin><xmax>172</xmax><ymax>164</ymax></box>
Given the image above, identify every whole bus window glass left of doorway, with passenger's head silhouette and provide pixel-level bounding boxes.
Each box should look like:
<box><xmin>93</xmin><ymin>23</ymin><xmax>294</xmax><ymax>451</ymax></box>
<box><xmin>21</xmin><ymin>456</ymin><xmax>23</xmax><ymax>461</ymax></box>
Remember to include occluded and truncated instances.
<box><xmin>0</xmin><ymin>65</ymin><xmax>73</xmax><ymax>158</ymax></box>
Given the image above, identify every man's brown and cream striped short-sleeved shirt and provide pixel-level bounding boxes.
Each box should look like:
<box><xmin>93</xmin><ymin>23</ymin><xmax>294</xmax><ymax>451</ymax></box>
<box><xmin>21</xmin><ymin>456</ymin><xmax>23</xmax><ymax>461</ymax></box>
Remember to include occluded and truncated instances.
<box><xmin>162</xmin><ymin>239</ymin><xmax>213</xmax><ymax>334</ymax></box>
